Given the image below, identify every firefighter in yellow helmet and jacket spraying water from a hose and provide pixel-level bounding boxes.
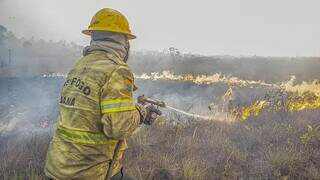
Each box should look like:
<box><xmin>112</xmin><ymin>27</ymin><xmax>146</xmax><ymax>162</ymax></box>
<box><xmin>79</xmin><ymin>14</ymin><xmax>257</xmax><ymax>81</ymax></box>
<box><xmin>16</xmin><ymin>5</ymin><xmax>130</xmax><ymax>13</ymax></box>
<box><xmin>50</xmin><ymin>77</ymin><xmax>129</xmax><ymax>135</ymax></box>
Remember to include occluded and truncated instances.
<box><xmin>45</xmin><ymin>8</ymin><xmax>156</xmax><ymax>180</ymax></box>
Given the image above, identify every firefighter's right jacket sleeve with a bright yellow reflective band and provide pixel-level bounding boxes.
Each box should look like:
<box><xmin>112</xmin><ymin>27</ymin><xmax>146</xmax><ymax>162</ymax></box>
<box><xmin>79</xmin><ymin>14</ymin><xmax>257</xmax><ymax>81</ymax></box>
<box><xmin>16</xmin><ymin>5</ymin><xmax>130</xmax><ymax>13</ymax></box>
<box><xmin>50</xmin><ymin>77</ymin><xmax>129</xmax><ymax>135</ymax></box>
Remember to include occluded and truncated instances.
<box><xmin>100</xmin><ymin>66</ymin><xmax>140</xmax><ymax>140</ymax></box>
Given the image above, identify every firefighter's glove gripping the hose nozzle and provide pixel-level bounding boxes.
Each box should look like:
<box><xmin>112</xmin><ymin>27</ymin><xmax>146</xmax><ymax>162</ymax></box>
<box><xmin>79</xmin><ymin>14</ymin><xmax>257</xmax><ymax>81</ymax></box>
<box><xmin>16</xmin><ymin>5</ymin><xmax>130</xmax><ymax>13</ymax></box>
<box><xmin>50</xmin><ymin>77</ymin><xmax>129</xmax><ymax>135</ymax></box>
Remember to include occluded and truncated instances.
<box><xmin>136</xmin><ymin>103</ymin><xmax>162</xmax><ymax>125</ymax></box>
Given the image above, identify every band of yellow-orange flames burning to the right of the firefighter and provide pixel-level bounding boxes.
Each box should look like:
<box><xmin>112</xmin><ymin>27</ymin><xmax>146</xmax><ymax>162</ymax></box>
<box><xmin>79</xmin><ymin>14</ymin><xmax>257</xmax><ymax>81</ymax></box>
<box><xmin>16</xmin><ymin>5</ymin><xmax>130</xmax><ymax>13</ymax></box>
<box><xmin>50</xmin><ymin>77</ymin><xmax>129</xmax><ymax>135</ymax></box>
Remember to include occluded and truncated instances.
<box><xmin>136</xmin><ymin>71</ymin><xmax>320</xmax><ymax>120</ymax></box>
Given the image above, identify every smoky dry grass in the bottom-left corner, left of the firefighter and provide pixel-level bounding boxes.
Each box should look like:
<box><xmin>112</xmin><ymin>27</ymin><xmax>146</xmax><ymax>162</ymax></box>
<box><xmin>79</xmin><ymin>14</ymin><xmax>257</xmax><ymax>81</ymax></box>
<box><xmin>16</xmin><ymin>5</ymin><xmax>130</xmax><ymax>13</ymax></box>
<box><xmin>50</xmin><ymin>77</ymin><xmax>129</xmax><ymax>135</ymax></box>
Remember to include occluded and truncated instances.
<box><xmin>0</xmin><ymin>131</ymin><xmax>50</xmax><ymax>180</ymax></box>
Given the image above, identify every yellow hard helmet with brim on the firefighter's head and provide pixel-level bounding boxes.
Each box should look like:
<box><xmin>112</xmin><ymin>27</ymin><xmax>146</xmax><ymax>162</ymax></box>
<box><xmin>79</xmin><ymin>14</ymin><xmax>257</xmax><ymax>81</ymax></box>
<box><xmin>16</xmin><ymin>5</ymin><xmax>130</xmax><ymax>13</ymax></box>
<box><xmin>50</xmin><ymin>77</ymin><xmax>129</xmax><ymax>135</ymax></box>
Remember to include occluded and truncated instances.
<box><xmin>82</xmin><ymin>8</ymin><xmax>136</xmax><ymax>39</ymax></box>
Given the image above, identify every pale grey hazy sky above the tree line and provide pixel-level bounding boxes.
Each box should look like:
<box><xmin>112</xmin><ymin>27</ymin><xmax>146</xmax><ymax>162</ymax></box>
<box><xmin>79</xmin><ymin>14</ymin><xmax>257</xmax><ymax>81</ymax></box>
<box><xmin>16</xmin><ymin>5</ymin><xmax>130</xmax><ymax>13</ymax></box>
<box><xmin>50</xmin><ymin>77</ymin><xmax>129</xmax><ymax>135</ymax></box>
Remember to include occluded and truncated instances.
<box><xmin>0</xmin><ymin>0</ymin><xmax>320</xmax><ymax>56</ymax></box>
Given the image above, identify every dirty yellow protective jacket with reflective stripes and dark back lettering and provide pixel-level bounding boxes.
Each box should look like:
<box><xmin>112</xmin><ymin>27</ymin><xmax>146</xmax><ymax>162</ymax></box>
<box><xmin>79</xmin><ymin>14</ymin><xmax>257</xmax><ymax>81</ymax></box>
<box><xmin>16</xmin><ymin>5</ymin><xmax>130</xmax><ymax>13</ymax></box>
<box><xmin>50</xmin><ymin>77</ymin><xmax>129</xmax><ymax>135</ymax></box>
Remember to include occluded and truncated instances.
<box><xmin>45</xmin><ymin>44</ymin><xmax>140</xmax><ymax>180</ymax></box>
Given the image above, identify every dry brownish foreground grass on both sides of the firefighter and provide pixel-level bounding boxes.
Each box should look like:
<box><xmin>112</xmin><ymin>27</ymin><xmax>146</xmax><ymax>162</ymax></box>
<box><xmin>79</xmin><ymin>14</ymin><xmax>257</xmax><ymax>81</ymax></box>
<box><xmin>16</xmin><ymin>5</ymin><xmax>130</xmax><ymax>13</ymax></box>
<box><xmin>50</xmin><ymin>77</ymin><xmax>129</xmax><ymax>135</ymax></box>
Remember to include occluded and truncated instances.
<box><xmin>0</xmin><ymin>111</ymin><xmax>320</xmax><ymax>180</ymax></box>
